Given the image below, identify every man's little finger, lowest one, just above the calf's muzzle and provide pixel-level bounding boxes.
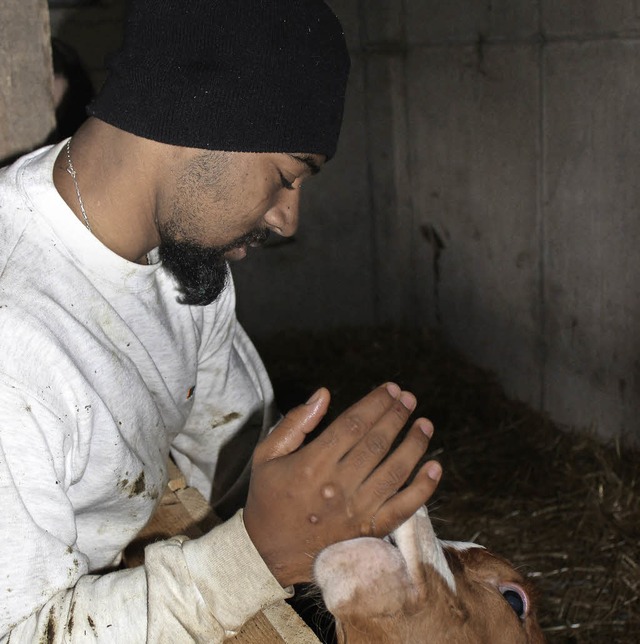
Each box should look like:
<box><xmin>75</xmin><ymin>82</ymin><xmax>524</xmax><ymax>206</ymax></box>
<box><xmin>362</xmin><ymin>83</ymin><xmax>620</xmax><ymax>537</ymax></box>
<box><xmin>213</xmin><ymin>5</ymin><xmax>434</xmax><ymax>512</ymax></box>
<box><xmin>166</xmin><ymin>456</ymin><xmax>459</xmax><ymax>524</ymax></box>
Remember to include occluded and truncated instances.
<box><xmin>371</xmin><ymin>461</ymin><xmax>442</xmax><ymax>537</ymax></box>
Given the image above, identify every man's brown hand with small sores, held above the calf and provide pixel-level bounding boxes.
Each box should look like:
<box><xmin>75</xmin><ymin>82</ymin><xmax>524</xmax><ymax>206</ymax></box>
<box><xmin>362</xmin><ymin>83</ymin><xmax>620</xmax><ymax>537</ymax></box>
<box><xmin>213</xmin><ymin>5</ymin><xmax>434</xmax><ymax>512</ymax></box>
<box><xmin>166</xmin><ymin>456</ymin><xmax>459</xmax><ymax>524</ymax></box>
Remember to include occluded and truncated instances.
<box><xmin>244</xmin><ymin>383</ymin><xmax>442</xmax><ymax>586</ymax></box>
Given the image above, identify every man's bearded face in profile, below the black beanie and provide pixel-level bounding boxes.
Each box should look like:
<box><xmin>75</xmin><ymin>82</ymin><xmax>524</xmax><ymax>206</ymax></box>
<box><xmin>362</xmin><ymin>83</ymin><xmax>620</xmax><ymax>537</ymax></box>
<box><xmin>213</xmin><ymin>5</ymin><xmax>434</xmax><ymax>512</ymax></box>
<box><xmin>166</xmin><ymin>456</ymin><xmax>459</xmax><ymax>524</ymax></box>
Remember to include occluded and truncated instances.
<box><xmin>157</xmin><ymin>149</ymin><xmax>324</xmax><ymax>305</ymax></box>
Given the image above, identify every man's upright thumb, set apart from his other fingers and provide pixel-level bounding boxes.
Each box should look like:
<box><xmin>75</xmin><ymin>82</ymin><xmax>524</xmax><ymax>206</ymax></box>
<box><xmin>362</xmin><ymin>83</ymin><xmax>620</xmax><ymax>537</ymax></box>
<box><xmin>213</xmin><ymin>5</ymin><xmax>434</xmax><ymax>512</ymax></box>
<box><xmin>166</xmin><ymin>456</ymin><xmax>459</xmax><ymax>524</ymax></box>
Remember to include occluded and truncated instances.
<box><xmin>253</xmin><ymin>387</ymin><xmax>331</xmax><ymax>463</ymax></box>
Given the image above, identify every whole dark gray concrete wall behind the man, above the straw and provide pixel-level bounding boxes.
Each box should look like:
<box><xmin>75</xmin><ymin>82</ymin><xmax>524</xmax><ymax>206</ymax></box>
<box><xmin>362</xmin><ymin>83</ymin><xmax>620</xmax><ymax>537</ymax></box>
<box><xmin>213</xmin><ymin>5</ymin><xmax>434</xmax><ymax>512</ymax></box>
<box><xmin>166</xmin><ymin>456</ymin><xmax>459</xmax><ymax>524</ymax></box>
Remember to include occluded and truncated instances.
<box><xmin>45</xmin><ymin>0</ymin><xmax>640</xmax><ymax>441</ymax></box>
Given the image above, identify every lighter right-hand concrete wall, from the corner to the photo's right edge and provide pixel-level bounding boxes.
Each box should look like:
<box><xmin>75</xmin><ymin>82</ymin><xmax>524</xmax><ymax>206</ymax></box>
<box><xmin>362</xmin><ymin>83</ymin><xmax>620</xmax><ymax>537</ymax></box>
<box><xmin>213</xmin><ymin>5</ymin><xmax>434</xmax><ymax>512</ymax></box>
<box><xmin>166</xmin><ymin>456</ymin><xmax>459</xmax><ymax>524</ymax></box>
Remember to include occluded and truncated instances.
<box><xmin>397</xmin><ymin>0</ymin><xmax>640</xmax><ymax>441</ymax></box>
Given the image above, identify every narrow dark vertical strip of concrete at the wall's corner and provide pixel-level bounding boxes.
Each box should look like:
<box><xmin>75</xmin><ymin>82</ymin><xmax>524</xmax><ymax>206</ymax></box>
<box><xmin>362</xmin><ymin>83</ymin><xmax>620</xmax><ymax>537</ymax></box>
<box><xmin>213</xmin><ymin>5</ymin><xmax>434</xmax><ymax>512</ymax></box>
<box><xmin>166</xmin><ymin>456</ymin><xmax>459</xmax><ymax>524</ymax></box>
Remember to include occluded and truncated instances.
<box><xmin>360</xmin><ymin>0</ymin><xmax>421</xmax><ymax>324</ymax></box>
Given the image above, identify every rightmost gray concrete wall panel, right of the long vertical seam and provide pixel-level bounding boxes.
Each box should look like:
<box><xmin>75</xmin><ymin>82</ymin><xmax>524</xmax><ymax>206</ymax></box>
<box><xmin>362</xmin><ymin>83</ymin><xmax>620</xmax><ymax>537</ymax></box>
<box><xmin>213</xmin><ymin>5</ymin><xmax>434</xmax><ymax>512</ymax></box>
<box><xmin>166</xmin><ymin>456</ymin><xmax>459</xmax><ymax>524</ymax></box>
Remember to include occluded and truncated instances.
<box><xmin>544</xmin><ymin>38</ymin><xmax>640</xmax><ymax>438</ymax></box>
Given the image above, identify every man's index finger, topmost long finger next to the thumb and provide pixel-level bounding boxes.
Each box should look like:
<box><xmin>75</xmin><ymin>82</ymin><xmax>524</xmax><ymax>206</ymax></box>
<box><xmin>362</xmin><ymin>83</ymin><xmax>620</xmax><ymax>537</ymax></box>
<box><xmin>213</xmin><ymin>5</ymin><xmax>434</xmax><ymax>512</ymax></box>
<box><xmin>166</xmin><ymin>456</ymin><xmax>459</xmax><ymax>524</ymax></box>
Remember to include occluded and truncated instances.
<box><xmin>309</xmin><ymin>383</ymin><xmax>410</xmax><ymax>463</ymax></box>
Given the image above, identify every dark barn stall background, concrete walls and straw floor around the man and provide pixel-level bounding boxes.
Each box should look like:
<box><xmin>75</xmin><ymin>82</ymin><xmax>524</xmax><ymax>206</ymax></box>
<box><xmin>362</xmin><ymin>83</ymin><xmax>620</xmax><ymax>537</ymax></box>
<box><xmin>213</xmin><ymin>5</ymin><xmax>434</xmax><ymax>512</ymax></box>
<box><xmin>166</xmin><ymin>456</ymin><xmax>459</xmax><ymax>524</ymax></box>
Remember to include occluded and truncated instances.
<box><xmin>0</xmin><ymin>0</ymin><xmax>640</xmax><ymax>643</ymax></box>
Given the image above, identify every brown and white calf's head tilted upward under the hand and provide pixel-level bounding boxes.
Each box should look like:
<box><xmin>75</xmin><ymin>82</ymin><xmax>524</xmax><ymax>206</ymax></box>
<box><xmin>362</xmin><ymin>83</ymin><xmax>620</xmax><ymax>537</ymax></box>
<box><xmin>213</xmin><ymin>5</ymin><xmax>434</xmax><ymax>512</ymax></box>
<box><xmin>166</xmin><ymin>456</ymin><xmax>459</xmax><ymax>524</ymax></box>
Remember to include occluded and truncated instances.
<box><xmin>315</xmin><ymin>508</ymin><xmax>545</xmax><ymax>644</ymax></box>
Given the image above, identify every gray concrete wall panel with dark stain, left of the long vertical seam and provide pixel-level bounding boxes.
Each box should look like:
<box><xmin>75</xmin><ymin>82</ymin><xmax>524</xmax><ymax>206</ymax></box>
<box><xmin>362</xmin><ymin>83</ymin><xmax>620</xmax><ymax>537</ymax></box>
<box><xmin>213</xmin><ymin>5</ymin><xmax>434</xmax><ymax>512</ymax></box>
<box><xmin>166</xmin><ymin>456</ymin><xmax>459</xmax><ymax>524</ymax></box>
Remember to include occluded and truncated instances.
<box><xmin>407</xmin><ymin>44</ymin><xmax>542</xmax><ymax>405</ymax></box>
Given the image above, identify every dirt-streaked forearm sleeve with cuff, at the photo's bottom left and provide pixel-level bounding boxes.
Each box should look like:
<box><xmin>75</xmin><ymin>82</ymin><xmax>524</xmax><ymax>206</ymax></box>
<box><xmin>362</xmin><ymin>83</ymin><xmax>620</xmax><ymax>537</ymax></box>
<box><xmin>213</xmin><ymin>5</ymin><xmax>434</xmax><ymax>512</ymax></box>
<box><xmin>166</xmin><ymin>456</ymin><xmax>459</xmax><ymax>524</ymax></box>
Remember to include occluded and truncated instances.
<box><xmin>0</xmin><ymin>511</ymin><xmax>291</xmax><ymax>644</ymax></box>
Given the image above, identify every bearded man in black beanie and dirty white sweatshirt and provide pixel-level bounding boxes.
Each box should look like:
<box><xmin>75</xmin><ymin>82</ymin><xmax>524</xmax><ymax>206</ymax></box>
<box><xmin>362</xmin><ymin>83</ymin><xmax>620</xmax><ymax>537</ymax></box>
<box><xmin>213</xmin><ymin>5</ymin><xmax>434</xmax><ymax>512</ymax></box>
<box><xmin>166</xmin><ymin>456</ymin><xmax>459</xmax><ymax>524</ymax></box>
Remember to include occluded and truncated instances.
<box><xmin>0</xmin><ymin>0</ymin><xmax>440</xmax><ymax>644</ymax></box>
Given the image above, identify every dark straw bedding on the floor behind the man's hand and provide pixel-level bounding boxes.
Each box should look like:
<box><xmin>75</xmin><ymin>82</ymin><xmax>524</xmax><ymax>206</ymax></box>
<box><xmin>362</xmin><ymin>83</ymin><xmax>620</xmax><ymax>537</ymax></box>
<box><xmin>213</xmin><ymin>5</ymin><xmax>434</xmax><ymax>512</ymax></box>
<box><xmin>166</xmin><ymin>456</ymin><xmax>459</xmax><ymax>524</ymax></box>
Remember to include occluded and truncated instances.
<box><xmin>257</xmin><ymin>328</ymin><xmax>640</xmax><ymax>644</ymax></box>
